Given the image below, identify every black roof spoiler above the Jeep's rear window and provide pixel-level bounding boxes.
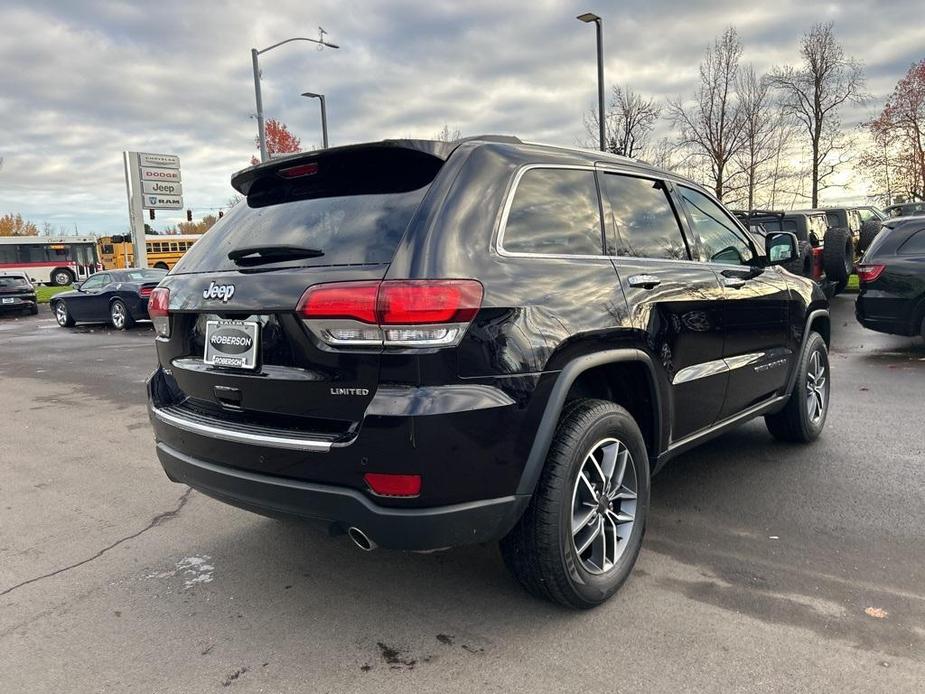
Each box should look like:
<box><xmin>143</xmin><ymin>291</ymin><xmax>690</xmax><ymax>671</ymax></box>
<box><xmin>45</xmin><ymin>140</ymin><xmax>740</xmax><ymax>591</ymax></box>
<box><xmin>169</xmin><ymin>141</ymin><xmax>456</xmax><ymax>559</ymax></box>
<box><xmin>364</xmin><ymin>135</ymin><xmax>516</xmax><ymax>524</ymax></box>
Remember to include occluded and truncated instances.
<box><xmin>231</xmin><ymin>135</ymin><xmax>520</xmax><ymax>195</ymax></box>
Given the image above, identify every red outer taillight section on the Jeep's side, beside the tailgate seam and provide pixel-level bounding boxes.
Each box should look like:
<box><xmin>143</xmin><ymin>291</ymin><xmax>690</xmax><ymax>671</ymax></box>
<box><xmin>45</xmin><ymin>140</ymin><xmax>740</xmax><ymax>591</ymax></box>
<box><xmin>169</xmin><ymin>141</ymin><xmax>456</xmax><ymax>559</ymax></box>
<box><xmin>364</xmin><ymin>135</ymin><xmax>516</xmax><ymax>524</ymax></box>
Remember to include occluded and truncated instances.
<box><xmin>379</xmin><ymin>280</ymin><xmax>482</xmax><ymax>325</ymax></box>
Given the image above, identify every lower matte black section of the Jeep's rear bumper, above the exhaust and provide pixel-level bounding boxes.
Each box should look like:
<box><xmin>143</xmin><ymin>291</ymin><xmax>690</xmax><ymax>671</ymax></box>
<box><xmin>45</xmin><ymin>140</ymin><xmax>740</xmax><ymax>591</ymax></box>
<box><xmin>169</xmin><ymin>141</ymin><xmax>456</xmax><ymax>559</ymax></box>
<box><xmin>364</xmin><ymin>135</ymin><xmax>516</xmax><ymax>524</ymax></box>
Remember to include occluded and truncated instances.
<box><xmin>157</xmin><ymin>442</ymin><xmax>530</xmax><ymax>550</ymax></box>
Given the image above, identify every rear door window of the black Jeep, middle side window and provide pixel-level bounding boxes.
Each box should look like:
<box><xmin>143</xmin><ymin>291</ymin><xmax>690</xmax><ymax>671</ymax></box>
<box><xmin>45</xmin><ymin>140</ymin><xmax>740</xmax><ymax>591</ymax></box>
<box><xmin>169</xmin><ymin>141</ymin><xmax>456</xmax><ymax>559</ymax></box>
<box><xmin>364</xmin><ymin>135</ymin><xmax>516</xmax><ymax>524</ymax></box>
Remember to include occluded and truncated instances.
<box><xmin>603</xmin><ymin>174</ymin><xmax>688</xmax><ymax>260</ymax></box>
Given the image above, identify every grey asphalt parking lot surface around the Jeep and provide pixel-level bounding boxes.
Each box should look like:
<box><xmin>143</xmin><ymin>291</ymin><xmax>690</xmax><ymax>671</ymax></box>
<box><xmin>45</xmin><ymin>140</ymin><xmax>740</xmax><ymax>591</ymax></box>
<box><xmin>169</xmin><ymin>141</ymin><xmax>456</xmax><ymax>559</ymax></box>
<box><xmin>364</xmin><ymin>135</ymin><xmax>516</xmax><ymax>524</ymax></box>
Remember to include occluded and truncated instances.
<box><xmin>0</xmin><ymin>296</ymin><xmax>925</xmax><ymax>694</ymax></box>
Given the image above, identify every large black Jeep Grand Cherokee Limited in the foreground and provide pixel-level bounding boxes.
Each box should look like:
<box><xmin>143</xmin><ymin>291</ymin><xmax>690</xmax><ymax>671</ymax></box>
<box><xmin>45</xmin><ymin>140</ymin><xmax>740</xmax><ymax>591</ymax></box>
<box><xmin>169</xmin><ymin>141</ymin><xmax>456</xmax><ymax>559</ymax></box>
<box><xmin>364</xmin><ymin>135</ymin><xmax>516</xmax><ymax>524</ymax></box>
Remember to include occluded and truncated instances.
<box><xmin>148</xmin><ymin>137</ymin><xmax>829</xmax><ymax>607</ymax></box>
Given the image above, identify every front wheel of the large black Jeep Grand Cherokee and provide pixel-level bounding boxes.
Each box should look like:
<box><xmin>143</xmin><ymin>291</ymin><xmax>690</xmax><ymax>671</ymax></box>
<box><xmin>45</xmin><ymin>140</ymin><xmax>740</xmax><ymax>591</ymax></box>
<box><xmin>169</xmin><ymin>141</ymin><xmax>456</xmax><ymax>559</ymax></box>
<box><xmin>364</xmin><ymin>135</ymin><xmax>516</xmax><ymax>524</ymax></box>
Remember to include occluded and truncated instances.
<box><xmin>764</xmin><ymin>332</ymin><xmax>831</xmax><ymax>443</ymax></box>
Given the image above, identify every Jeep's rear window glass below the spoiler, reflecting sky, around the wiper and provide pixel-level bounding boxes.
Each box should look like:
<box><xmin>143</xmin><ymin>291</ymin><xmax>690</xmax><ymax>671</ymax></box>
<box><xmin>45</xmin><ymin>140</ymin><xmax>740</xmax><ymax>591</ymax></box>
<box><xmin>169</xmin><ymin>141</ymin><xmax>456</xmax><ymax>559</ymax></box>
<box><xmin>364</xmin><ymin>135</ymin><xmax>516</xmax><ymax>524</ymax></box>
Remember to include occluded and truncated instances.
<box><xmin>173</xmin><ymin>186</ymin><xmax>427</xmax><ymax>274</ymax></box>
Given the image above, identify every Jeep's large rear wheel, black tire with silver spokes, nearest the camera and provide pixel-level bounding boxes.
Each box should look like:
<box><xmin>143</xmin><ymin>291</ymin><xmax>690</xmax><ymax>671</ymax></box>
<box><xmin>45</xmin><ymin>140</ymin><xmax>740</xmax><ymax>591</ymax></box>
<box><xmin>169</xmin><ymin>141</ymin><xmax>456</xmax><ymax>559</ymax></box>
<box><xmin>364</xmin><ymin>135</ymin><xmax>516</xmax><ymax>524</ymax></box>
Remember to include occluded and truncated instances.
<box><xmin>501</xmin><ymin>399</ymin><xmax>649</xmax><ymax>609</ymax></box>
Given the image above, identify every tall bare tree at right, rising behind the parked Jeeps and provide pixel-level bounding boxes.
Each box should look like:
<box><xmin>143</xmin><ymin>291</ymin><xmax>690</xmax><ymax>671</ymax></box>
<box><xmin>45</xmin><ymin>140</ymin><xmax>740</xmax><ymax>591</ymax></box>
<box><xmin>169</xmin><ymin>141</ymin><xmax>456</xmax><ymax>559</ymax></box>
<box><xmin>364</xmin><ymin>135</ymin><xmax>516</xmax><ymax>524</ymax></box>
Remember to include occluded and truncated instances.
<box><xmin>771</xmin><ymin>22</ymin><xmax>864</xmax><ymax>207</ymax></box>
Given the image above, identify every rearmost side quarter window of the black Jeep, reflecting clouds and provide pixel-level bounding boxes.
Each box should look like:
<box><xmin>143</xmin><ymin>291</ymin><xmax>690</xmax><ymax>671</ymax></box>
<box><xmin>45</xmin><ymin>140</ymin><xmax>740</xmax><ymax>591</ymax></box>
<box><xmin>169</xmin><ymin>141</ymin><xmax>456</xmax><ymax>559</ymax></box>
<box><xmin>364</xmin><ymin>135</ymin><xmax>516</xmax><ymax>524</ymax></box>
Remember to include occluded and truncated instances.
<box><xmin>502</xmin><ymin>169</ymin><xmax>603</xmax><ymax>255</ymax></box>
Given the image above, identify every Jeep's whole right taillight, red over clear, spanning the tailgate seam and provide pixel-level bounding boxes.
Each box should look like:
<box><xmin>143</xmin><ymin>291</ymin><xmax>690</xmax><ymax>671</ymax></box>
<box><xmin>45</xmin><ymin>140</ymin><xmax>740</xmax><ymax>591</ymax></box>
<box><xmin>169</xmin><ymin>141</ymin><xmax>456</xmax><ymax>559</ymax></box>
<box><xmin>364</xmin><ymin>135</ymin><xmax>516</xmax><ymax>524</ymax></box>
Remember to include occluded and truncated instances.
<box><xmin>298</xmin><ymin>280</ymin><xmax>482</xmax><ymax>347</ymax></box>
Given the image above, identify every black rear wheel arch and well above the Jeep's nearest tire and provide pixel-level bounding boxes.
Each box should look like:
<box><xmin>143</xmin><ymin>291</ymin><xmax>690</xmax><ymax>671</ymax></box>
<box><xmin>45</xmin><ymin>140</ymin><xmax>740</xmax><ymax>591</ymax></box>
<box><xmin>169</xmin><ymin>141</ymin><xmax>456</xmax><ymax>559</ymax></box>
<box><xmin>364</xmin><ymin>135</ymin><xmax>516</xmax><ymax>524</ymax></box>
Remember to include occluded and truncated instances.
<box><xmin>516</xmin><ymin>348</ymin><xmax>662</xmax><ymax>495</ymax></box>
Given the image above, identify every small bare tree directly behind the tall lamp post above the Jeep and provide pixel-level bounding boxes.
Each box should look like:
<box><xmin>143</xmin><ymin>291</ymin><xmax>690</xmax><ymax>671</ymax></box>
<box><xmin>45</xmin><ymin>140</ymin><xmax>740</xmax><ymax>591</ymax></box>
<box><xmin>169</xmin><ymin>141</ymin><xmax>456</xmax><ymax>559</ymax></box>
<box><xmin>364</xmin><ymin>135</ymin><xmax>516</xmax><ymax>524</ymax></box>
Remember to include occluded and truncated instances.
<box><xmin>584</xmin><ymin>85</ymin><xmax>662</xmax><ymax>157</ymax></box>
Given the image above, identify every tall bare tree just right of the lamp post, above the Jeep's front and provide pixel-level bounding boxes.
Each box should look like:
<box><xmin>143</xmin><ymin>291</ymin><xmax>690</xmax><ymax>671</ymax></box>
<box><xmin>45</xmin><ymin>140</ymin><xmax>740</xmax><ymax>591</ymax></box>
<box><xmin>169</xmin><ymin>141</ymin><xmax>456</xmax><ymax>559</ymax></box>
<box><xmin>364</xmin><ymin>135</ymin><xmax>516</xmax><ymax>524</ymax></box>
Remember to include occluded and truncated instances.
<box><xmin>668</xmin><ymin>27</ymin><xmax>744</xmax><ymax>200</ymax></box>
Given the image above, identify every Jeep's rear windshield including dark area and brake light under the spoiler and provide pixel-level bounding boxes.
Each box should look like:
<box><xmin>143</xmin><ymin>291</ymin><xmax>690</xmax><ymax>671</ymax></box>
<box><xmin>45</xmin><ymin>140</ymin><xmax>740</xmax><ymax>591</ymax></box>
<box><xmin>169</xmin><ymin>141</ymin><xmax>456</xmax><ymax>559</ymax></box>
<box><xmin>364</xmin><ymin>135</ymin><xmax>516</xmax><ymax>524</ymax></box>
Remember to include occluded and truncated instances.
<box><xmin>173</xmin><ymin>148</ymin><xmax>443</xmax><ymax>275</ymax></box>
